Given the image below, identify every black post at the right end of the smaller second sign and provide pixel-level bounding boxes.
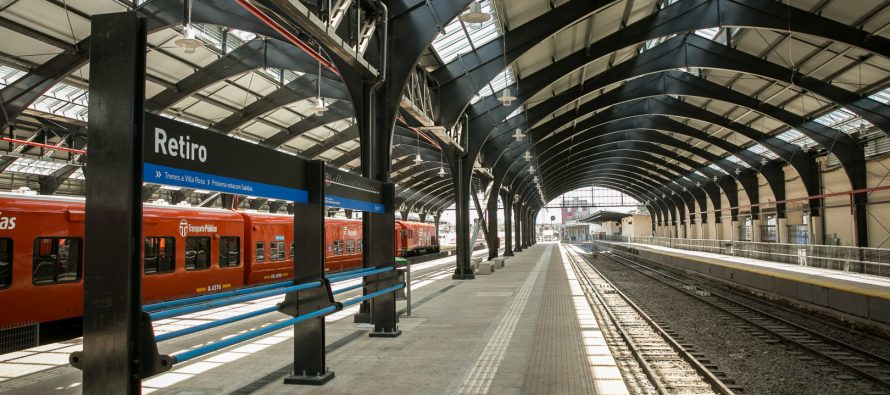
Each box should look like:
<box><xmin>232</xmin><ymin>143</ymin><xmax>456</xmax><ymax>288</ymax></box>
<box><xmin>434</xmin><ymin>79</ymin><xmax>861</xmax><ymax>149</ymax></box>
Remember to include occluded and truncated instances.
<box><xmin>365</xmin><ymin>182</ymin><xmax>402</xmax><ymax>337</ymax></box>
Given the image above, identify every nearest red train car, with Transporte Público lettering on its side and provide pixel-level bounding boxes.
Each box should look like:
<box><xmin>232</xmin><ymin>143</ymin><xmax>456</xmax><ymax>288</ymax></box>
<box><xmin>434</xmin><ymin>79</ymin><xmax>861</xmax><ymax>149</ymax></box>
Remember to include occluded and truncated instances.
<box><xmin>0</xmin><ymin>194</ymin><xmax>244</xmax><ymax>327</ymax></box>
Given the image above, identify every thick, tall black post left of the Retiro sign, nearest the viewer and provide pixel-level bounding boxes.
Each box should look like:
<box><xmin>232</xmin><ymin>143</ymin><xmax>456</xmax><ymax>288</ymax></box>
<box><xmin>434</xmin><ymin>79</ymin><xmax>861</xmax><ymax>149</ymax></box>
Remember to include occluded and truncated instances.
<box><xmin>83</xmin><ymin>12</ymin><xmax>151</xmax><ymax>394</ymax></box>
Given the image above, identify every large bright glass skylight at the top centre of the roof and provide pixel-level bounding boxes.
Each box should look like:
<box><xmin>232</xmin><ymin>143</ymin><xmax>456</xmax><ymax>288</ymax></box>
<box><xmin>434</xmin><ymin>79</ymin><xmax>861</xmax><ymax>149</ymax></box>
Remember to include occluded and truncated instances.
<box><xmin>433</xmin><ymin>0</ymin><xmax>501</xmax><ymax>64</ymax></box>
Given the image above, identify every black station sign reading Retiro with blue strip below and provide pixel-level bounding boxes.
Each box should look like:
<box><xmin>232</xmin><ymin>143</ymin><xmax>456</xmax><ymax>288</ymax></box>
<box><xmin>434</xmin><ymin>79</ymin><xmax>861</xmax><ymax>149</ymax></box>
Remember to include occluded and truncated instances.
<box><xmin>142</xmin><ymin>113</ymin><xmax>309</xmax><ymax>203</ymax></box>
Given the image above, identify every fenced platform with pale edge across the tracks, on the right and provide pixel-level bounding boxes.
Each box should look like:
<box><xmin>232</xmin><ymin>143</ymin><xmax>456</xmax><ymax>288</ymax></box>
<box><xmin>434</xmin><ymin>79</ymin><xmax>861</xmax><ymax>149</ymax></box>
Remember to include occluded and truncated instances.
<box><xmin>597</xmin><ymin>241</ymin><xmax>890</xmax><ymax>333</ymax></box>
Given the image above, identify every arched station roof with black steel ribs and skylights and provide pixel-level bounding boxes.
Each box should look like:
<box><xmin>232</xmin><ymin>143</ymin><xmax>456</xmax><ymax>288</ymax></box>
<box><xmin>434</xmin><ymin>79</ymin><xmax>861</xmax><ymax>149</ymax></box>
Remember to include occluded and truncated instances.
<box><xmin>0</xmin><ymin>0</ymin><xmax>890</xmax><ymax>226</ymax></box>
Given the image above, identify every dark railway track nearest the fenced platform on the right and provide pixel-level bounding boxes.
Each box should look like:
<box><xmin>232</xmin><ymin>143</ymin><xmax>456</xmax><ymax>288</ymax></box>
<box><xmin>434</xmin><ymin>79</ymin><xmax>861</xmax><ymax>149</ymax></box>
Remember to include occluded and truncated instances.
<box><xmin>588</xmin><ymin>246</ymin><xmax>890</xmax><ymax>393</ymax></box>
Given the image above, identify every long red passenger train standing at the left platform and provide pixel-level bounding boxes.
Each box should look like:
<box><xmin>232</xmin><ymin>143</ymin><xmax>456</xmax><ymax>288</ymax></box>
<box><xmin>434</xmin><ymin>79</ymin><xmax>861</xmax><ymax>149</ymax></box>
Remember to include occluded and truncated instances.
<box><xmin>0</xmin><ymin>194</ymin><xmax>438</xmax><ymax>336</ymax></box>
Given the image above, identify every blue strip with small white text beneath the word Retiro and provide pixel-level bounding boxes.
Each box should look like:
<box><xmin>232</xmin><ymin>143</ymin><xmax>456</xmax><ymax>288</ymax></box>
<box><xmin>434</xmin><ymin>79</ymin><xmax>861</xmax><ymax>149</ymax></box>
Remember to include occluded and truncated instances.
<box><xmin>142</xmin><ymin>162</ymin><xmax>309</xmax><ymax>203</ymax></box>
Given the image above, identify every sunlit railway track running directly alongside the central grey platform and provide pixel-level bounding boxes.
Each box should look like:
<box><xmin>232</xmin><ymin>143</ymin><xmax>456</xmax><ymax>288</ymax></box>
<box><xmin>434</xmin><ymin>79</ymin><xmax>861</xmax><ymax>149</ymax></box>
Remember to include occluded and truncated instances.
<box><xmin>566</xmin><ymin>248</ymin><xmax>733</xmax><ymax>394</ymax></box>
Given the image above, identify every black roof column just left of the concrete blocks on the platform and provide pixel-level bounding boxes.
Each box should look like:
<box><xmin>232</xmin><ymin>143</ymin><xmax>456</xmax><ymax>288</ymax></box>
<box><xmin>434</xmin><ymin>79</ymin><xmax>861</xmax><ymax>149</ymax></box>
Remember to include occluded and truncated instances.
<box><xmin>451</xmin><ymin>156</ymin><xmax>476</xmax><ymax>280</ymax></box>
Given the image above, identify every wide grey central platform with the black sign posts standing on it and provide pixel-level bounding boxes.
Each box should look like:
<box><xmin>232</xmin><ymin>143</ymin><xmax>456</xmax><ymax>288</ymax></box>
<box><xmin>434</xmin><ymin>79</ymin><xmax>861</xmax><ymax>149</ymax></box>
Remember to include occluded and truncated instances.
<box><xmin>0</xmin><ymin>244</ymin><xmax>627</xmax><ymax>394</ymax></box>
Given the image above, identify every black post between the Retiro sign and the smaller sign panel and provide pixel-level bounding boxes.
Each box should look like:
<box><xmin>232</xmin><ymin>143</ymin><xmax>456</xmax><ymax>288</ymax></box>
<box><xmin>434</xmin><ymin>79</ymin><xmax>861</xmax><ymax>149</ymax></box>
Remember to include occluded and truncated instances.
<box><xmin>283</xmin><ymin>161</ymin><xmax>334</xmax><ymax>385</ymax></box>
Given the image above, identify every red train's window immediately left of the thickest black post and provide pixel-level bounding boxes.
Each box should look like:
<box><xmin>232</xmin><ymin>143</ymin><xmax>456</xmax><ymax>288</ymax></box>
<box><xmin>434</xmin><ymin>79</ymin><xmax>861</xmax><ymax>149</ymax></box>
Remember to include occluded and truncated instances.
<box><xmin>31</xmin><ymin>237</ymin><xmax>82</xmax><ymax>285</ymax></box>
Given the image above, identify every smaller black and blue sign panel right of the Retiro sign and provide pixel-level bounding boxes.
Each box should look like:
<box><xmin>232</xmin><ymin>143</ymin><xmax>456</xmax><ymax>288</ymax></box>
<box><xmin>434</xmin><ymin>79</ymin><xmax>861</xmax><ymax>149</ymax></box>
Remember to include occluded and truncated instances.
<box><xmin>324</xmin><ymin>167</ymin><xmax>386</xmax><ymax>213</ymax></box>
